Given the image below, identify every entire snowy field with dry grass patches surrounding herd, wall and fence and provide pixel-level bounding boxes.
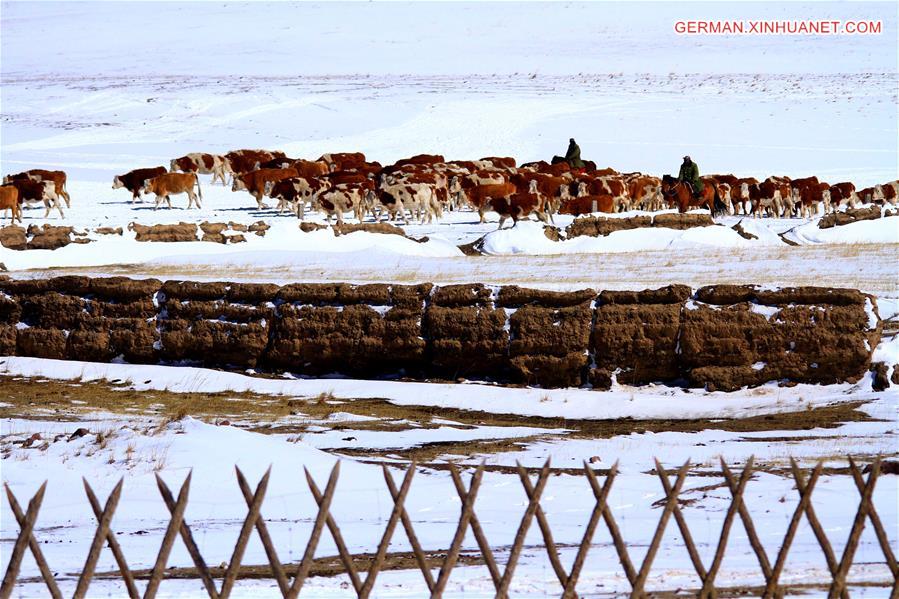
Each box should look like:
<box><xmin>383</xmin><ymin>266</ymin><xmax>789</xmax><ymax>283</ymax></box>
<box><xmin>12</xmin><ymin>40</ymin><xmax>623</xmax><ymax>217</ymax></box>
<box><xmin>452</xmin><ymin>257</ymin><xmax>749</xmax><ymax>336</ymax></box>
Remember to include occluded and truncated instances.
<box><xmin>0</xmin><ymin>2</ymin><xmax>899</xmax><ymax>598</ymax></box>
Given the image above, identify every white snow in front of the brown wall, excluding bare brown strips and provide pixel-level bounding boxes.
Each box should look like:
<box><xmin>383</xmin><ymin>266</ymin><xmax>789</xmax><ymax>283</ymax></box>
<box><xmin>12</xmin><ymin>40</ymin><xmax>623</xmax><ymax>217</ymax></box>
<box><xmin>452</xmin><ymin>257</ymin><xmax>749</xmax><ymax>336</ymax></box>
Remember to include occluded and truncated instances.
<box><xmin>0</xmin><ymin>352</ymin><xmax>899</xmax><ymax>597</ymax></box>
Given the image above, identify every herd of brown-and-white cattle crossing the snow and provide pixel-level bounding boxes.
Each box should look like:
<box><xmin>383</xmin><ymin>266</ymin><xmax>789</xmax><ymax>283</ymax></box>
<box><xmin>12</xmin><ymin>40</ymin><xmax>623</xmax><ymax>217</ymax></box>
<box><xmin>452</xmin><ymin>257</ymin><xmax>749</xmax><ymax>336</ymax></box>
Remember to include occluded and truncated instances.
<box><xmin>0</xmin><ymin>150</ymin><xmax>899</xmax><ymax>228</ymax></box>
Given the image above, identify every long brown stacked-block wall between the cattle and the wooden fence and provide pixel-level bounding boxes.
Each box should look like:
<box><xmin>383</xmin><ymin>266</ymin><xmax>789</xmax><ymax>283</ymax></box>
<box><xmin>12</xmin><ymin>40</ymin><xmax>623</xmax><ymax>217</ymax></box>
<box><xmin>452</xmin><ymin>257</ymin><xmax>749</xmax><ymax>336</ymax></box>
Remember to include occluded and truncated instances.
<box><xmin>0</xmin><ymin>276</ymin><xmax>881</xmax><ymax>391</ymax></box>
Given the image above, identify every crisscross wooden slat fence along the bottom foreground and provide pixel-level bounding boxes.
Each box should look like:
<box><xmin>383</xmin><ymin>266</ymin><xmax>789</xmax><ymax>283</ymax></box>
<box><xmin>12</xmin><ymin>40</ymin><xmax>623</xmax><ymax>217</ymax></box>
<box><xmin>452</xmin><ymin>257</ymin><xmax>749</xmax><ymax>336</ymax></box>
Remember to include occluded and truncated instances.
<box><xmin>0</xmin><ymin>458</ymin><xmax>899</xmax><ymax>599</ymax></box>
